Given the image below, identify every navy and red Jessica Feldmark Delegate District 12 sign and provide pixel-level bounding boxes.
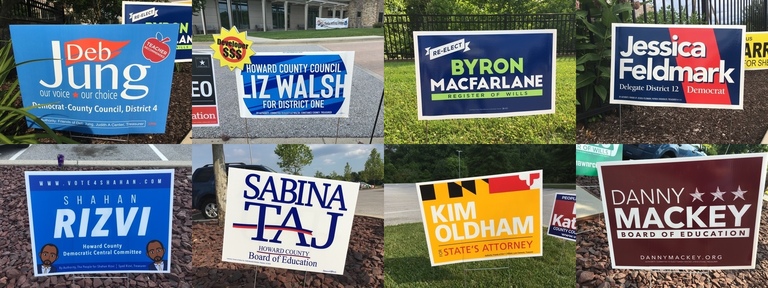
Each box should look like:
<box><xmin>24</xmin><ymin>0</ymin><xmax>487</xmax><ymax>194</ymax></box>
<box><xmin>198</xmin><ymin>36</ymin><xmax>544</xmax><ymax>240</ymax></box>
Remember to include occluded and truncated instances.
<box><xmin>609</xmin><ymin>23</ymin><xmax>745</xmax><ymax>109</ymax></box>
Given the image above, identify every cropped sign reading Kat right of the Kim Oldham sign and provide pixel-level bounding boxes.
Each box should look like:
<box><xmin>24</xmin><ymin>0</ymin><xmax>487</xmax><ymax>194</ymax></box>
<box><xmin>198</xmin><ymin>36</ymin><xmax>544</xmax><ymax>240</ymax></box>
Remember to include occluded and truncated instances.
<box><xmin>547</xmin><ymin>193</ymin><xmax>576</xmax><ymax>241</ymax></box>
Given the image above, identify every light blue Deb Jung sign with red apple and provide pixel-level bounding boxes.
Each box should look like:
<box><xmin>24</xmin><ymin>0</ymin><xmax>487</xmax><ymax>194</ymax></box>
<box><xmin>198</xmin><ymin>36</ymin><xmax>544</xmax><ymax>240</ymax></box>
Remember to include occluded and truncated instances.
<box><xmin>10</xmin><ymin>24</ymin><xmax>179</xmax><ymax>135</ymax></box>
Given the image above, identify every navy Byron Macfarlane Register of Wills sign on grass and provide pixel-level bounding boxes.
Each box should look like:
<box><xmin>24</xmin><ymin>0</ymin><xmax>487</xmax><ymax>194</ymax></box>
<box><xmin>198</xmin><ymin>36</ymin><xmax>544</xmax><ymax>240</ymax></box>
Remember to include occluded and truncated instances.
<box><xmin>413</xmin><ymin>30</ymin><xmax>557</xmax><ymax>120</ymax></box>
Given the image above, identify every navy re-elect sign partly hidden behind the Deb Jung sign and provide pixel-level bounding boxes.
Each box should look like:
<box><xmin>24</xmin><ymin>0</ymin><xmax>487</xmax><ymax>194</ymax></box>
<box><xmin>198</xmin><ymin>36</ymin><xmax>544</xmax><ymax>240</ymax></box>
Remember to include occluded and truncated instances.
<box><xmin>123</xmin><ymin>1</ymin><xmax>192</xmax><ymax>62</ymax></box>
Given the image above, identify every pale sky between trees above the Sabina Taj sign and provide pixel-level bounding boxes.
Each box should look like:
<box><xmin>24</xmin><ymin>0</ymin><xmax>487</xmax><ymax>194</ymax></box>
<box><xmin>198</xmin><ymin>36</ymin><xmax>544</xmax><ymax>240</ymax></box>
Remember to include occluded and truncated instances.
<box><xmin>192</xmin><ymin>144</ymin><xmax>384</xmax><ymax>176</ymax></box>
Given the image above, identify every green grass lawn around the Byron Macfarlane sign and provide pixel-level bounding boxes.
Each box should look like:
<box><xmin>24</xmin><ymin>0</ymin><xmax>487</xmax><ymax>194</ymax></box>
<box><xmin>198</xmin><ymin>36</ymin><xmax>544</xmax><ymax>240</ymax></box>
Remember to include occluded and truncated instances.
<box><xmin>384</xmin><ymin>57</ymin><xmax>576</xmax><ymax>144</ymax></box>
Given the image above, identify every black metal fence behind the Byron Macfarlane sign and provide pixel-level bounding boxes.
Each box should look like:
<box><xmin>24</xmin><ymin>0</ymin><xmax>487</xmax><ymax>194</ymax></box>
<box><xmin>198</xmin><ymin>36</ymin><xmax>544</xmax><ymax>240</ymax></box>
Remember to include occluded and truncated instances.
<box><xmin>384</xmin><ymin>14</ymin><xmax>576</xmax><ymax>60</ymax></box>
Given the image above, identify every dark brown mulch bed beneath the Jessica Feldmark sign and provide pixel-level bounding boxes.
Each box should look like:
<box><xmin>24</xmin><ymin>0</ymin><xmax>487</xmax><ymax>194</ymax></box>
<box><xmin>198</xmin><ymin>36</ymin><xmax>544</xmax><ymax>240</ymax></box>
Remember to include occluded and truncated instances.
<box><xmin>576</xmin><ymin>70</ymin><xmax>768</xmax><ymax>144</ymax></box>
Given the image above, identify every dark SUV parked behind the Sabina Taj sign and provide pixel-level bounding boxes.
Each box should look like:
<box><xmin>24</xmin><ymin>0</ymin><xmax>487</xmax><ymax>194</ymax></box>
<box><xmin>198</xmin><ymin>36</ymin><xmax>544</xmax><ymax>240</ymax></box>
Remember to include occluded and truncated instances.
<box><xmin>192</xmin><ymin>163</ymin><xmax>277</xmax><ymax>219</ymax></box>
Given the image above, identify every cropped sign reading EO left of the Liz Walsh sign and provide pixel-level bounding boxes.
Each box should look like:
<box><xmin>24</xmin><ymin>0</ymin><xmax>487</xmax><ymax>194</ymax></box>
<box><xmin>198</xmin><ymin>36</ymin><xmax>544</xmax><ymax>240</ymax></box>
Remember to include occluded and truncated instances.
<box><xmin>192</xmin><ymin>53</ymin><xmax>219</xmax><ymax>127</ymax></box>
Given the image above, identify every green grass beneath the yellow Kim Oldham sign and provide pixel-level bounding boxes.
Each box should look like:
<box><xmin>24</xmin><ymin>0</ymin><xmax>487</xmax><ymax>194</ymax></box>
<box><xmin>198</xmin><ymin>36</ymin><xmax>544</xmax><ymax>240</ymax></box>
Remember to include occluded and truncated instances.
<box><xmin>384</xmin><ymin>223</ymin><xmax>576</xmax><ymax>288</ymax></box>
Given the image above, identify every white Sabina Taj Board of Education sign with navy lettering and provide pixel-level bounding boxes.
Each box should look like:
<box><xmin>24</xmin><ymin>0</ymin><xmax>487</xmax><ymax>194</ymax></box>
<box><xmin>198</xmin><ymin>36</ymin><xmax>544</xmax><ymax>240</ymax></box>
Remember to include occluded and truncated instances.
<box><xmin>221</xmin><ymin>168</ymin><xmax>360</xmax><ymax>275</ymax></box>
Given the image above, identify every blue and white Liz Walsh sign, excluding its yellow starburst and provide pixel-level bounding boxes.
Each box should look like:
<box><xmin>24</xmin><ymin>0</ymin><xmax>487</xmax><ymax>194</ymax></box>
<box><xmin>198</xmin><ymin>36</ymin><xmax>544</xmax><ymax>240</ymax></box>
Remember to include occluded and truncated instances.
<box><xmin>237</xmin><ymin>51</ymin><xmax>355</xmax><ymax>118</ymax></box>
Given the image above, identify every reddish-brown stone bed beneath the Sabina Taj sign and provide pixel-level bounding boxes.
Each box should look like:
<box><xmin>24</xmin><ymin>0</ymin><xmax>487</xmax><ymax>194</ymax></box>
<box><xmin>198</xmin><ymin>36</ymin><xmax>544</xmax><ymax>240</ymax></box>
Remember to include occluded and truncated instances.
<box><xmin>192</xmin><ymin>216</ymin><xmax>384</xmax><ymax>288</ymax></box>
